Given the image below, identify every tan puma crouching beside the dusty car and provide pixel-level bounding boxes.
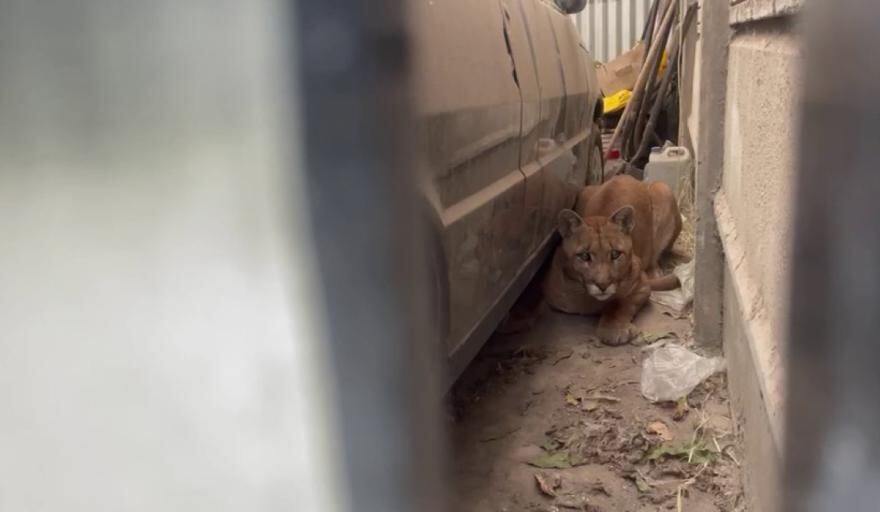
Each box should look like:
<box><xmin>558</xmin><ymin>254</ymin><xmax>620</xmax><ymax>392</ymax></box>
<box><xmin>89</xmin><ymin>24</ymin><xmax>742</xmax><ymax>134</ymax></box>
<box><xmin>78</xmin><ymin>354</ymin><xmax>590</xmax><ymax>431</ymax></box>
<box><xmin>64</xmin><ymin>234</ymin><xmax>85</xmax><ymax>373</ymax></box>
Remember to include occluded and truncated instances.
<box><xmin>543</xmin><ymin>175</ymin><xmax>681</xmax><ymax>345</ymax></box>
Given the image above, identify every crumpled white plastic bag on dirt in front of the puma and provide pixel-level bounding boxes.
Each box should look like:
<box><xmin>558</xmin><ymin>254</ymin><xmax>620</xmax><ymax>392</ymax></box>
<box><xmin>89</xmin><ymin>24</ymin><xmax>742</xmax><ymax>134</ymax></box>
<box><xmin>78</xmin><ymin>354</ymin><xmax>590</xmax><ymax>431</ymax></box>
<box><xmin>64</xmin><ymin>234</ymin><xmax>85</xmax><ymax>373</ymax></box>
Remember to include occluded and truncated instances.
<box><xmin>642</xmin><ymin>345</ymin><xmax>724</xmax><ymax>402</ymax></box>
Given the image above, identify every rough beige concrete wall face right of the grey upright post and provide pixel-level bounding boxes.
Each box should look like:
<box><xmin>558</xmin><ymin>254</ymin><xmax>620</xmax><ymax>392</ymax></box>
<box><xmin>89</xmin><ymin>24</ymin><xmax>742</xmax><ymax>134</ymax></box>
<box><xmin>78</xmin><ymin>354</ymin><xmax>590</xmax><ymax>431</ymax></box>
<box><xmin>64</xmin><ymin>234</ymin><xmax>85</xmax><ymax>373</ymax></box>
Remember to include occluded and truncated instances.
<box><xmin>714</xmin><ymin>8</ymin><xmax>800</xmax><ymax>511</ymax></box>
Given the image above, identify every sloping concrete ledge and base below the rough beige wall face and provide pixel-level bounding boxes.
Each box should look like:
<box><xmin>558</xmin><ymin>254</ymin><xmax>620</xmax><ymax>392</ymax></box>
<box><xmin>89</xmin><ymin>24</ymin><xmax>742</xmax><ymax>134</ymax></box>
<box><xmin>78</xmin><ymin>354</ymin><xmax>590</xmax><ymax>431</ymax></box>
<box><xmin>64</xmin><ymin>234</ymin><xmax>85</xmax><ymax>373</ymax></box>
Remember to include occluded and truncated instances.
<box><xmin>715</xmin><ymin>192</ymin><xmax>784</xmax><ymax>511</ymax></box>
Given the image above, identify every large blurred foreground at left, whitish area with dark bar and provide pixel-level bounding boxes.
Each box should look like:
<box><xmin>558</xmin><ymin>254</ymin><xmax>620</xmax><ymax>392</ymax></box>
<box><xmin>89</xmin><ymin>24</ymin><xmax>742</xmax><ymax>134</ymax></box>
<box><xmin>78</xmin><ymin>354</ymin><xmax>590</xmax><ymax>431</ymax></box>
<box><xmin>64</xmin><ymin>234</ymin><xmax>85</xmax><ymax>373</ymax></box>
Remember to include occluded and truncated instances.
<box><xmin>0</xmin><ymin>0</ymin><xmax>439</xmax><ymax>512</ymax></box>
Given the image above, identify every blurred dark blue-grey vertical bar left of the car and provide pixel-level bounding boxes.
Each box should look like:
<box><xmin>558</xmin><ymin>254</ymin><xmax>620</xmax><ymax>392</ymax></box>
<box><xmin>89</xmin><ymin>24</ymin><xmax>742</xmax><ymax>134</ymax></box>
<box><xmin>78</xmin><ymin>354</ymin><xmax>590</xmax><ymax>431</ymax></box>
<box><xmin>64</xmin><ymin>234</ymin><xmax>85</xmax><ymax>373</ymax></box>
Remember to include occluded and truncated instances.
<box><xmin>292</xmin><ymin>0</ymin><xmax>442</xmax><ymax>512</ymax></box>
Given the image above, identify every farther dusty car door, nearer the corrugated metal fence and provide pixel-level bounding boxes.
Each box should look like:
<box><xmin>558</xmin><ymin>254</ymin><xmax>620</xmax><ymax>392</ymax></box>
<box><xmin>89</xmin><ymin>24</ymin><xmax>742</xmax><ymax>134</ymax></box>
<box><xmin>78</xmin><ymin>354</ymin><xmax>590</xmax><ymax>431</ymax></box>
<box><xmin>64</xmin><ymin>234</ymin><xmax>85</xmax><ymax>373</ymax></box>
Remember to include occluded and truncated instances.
<box><xmin>502</xmin><ymin>0</ymin><xmax>595</xmax><ymax>260</ymax></box>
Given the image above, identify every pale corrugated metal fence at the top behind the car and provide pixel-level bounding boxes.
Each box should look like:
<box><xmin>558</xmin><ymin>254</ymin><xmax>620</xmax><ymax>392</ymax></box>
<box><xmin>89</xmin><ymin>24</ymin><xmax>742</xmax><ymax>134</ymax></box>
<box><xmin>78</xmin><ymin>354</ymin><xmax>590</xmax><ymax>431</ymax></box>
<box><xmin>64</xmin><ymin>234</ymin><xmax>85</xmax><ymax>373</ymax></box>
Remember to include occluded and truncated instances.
<box><xmin>575</xmin><ymin>0</ymin><xmax>651</xmax><ymax>62</ymax></box>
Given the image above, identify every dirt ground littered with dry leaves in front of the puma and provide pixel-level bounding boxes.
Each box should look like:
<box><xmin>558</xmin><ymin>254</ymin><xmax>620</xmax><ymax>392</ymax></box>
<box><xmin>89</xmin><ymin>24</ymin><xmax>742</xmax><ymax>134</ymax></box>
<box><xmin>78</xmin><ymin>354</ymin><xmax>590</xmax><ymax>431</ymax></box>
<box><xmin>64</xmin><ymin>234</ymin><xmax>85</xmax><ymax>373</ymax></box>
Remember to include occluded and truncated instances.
<box><xmin>450</xmin><ymin>304</ymin><xmax>743</xmax><ymax>512</ymax></box>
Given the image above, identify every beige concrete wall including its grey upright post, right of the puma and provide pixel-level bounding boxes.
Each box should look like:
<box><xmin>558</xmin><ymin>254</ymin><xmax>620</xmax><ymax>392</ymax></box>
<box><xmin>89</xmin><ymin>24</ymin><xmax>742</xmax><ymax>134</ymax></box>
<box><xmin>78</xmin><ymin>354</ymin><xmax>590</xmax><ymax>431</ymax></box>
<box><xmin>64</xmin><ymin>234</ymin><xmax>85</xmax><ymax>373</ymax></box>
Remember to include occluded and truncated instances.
<box><xmin>681</xmin><ymin>0</ymin><xmax>801</xmax><ymax>512</ymax></box>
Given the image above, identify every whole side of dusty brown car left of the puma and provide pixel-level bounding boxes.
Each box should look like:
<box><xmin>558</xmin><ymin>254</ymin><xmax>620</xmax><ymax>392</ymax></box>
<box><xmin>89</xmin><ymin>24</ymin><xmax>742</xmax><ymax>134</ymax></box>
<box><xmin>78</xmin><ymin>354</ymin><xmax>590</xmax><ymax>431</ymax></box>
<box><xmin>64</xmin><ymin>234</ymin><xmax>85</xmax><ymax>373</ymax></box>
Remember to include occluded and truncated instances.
<box><xmin>408</xmin><ymin>0</ymin><xmax>602</xmax><ymax>381</ymax></box>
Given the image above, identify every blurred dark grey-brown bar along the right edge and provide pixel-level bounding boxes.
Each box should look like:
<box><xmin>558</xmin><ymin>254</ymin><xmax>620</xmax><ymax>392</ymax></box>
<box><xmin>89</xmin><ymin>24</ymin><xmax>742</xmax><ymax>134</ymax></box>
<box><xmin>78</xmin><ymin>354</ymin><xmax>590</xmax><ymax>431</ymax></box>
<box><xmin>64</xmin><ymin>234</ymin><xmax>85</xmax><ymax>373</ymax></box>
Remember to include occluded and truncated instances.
<box><xmin>785</xmin><ymin>0</ymin><xmax>880</xmax><ymax>512</ymax></box>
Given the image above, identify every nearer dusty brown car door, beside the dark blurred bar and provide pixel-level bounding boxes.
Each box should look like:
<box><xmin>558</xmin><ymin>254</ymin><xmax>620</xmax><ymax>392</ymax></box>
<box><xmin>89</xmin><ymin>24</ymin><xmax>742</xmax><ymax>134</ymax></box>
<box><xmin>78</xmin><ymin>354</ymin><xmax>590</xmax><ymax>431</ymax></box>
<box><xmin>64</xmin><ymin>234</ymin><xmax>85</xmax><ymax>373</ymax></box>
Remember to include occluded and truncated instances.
<box><xmin>409</xmin><ymin>0</ymin><xmax>529</xmax><ymax>360</ymax></box>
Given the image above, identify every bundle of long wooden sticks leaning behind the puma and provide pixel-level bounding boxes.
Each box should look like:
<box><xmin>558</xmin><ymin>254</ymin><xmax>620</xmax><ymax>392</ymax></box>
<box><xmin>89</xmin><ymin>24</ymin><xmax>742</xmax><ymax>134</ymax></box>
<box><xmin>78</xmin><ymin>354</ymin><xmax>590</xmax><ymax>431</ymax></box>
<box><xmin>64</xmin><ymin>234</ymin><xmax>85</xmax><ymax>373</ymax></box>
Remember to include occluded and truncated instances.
<box><xmin>606</xmin><ymin>0</ymin><xmax>697</xmax><ymax>162</ymax></box>
